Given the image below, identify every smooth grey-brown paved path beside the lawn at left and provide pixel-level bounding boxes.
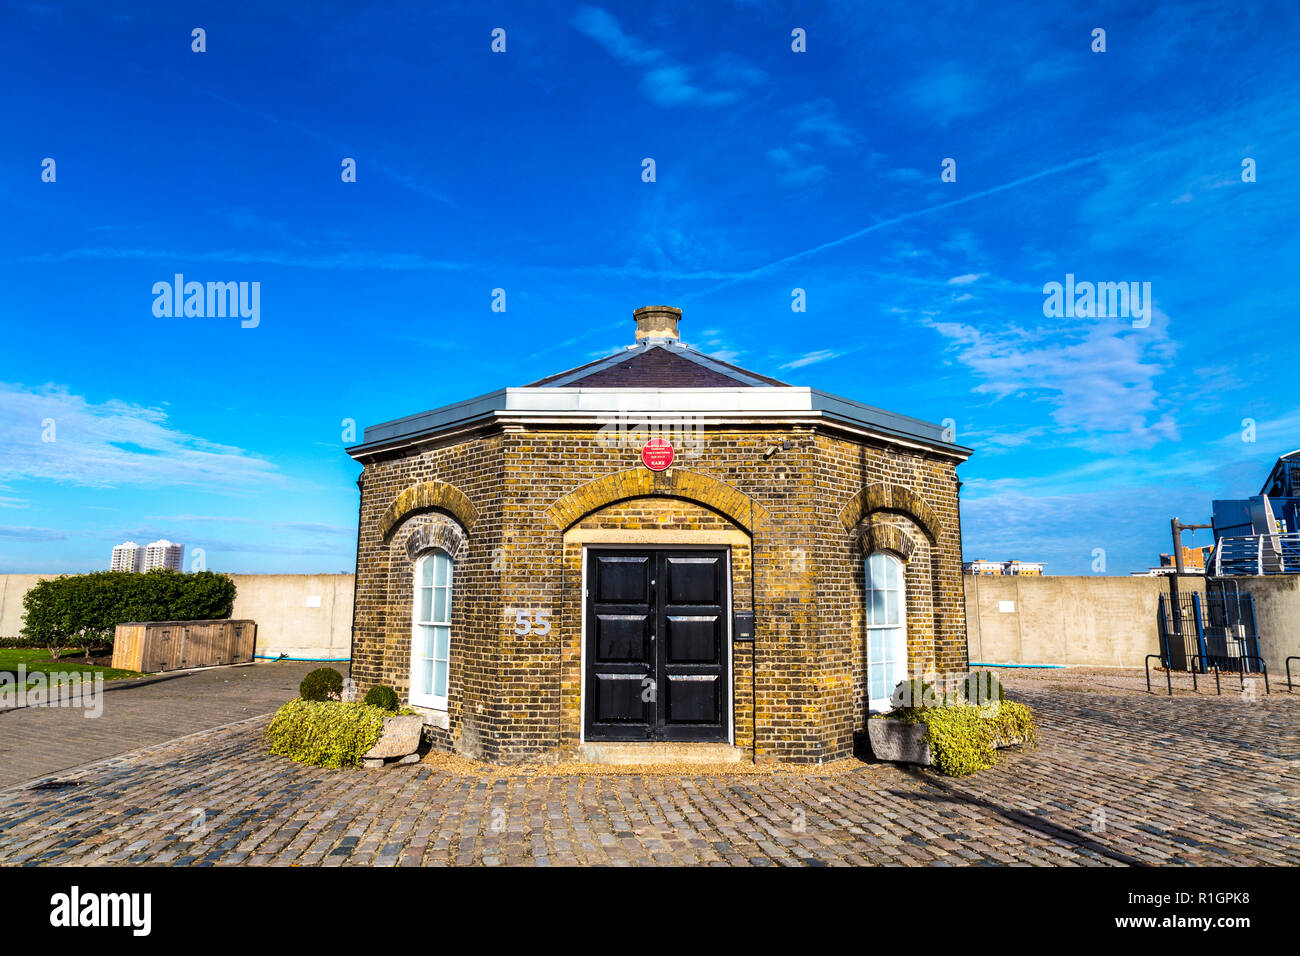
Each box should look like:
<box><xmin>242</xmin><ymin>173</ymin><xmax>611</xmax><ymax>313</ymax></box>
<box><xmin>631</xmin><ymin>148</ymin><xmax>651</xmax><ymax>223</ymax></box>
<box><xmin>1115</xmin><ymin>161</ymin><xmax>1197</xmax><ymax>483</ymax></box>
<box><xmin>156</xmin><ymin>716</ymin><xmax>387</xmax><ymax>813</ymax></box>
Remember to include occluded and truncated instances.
<box><xmin>0</xmin><ymin>661</ymin><xmax>320</xmax><ymax>787</ymax></box>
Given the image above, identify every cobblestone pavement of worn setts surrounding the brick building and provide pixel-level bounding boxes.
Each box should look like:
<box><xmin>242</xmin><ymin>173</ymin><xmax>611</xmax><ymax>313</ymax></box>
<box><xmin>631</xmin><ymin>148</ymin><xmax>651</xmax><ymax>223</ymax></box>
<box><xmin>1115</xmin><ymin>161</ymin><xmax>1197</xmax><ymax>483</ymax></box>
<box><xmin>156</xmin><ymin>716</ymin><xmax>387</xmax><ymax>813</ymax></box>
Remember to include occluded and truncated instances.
<box><xmin>0</xmin><ymin>683</ymin><xmax>1300</xmax><ymax>866</ymax></box>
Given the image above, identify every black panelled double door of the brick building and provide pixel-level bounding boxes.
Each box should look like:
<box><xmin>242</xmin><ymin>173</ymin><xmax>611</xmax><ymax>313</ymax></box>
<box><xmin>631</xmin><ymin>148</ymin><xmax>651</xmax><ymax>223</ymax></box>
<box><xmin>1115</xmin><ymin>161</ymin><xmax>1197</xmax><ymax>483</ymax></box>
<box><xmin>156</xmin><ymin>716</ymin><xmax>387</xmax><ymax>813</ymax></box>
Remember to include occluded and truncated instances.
<box><xmin>584</xmin><ymin>550</ymin><xmax>731</xmax><ymax>743</ymax></box>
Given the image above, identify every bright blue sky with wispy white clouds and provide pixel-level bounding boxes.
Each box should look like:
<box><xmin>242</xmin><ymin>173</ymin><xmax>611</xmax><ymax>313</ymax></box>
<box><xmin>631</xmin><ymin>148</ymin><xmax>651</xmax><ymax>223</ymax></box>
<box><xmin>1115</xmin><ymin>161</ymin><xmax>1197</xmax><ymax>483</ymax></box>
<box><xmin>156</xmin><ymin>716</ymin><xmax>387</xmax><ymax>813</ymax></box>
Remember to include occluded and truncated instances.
<box><xmin>0</xmin><ymin>0</ymin><xmax>1300</xmax><ymax>574</ymax></box>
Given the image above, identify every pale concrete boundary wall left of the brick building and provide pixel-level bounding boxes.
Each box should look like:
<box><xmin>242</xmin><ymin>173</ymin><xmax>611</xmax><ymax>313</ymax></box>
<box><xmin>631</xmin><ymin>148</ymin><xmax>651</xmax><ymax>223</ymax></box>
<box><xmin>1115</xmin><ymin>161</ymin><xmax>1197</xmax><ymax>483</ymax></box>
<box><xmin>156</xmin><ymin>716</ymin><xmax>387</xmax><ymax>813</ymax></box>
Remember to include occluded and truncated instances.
<box><xmin>0</xmin><ymin>574</ymin><xmax>352</xmax><ymax>659</ymax></box>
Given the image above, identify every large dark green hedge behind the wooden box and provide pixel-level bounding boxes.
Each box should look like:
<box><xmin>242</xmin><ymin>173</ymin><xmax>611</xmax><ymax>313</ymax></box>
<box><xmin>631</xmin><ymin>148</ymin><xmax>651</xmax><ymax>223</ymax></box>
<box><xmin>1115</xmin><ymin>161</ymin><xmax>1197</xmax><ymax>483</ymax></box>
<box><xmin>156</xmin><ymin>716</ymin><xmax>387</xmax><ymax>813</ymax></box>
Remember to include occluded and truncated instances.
<box><xmin>22</xmin><ymin>568</ymin><xmax>235</xmax><ymax>645</ymax></box>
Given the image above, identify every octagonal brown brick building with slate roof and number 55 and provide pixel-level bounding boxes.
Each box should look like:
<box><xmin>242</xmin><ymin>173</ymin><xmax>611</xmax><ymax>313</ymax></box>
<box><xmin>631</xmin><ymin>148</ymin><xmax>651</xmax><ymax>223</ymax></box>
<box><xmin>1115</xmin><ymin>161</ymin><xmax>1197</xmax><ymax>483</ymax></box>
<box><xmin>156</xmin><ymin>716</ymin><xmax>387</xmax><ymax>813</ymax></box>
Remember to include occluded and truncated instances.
<box><xmin>348</xmin><ymin>306</ymin><xmax>970</xmax><ymax>762</ymax></box>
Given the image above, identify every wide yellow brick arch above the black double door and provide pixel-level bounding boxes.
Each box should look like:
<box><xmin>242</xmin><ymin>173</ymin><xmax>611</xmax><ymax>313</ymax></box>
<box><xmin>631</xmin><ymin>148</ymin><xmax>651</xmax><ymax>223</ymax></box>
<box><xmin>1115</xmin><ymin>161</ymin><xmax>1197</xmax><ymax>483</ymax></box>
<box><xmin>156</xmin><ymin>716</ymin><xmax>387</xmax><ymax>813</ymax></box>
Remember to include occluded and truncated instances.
<box><xmin>546</xmin><ymin>468</ymin><xmax>771</xmax><ymax>533</ymax></box>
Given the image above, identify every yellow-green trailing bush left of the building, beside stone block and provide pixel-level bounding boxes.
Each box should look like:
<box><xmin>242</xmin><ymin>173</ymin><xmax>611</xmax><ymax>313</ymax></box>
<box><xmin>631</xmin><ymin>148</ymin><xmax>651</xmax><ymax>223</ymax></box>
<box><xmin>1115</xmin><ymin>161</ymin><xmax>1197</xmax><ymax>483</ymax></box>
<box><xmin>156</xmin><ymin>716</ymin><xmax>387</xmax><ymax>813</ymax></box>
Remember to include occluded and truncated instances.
<box><xmin>267</xmin><ymin>697</ymin><xmax>386</xmax><ymax>769</ymax></box>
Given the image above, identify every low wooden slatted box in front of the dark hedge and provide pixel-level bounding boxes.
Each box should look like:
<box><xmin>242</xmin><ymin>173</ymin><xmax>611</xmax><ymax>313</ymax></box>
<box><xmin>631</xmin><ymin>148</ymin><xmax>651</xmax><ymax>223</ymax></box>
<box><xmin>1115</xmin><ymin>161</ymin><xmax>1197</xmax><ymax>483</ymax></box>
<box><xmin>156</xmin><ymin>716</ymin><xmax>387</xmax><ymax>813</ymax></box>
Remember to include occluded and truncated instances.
<box><xmin>113</xmin><ymin>620</ymin><xmax>257</xmax><ymax>674</ymax></box>
